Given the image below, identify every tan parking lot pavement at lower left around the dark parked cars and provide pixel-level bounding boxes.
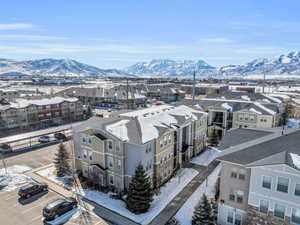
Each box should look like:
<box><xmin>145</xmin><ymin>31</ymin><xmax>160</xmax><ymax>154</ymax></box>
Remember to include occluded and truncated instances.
<box><xmin>0</xmin><ymin>141</ymin><xmax>106</xmax><ymax>225</ymax></box>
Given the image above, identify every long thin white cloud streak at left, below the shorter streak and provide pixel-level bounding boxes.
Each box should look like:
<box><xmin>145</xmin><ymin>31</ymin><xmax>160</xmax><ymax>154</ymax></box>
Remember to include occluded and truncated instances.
<box><xmin>0</xmin><ymin>34</ymin><xmax>69</xmax><ymax>41</ymax></box>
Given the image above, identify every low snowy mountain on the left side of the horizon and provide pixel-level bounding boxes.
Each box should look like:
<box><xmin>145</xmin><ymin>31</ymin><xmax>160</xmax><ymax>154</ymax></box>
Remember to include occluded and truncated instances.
<box><xmin>0</xmin><ymin>59</ymin><xmax>133</xmax><ymax>77</ymax></box>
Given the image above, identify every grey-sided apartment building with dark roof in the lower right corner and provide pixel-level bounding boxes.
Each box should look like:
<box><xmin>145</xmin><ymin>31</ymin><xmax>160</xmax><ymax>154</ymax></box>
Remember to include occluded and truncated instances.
<box><xmin>218</xmin><ymin>130</ymin><xmax>300</xmax><ymax>225</ymax></box>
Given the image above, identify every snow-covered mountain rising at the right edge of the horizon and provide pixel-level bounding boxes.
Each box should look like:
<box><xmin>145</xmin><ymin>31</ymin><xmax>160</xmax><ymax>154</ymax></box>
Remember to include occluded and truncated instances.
<box><xmin>219</xmin><ymin>52</ymin><xmax>300</xmax><ymax>76</ymax></box>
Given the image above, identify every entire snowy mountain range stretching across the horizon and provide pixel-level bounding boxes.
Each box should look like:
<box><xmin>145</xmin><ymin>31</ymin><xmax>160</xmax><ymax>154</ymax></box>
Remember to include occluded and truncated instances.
<box><xmin>0</xmin><ymin>52</ymin><xmax>300</xmax><ymax>78</ymax></box>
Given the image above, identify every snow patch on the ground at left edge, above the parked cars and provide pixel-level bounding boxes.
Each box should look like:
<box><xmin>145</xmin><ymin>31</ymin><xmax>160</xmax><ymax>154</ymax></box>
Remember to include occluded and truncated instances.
<box><xmin>0</xmin><ymin>165</ymin><xmax>31</xmax><ymax>191</ymax></box>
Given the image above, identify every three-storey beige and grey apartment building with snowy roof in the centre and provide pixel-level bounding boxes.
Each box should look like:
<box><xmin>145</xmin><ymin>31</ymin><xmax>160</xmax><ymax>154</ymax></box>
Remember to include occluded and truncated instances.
<box><xmin>74</xmin><ymin>105</ymin><xmax>207</xmax><ymax>192</ymax></box>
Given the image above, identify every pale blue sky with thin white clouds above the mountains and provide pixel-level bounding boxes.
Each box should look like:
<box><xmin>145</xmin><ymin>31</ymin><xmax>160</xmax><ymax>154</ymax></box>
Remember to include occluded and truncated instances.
<box><xmin>0</xmin><ymin>0</ymin><xmax>300</xmax><ymax>68</ymax></box>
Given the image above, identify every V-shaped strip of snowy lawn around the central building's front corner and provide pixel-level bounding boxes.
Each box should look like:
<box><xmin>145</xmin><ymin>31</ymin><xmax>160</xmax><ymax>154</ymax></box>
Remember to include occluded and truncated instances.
<box><xmin>78</xmin><ymin>168</ymin><xmax>198</xmax><ymax>225</ymax></box>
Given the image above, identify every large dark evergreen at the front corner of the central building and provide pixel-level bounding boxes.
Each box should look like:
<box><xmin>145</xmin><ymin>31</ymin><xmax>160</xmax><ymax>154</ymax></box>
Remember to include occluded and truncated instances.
<box><xmin>126</xmin><ymin>164</ymin><xmax>153</xmax><ymax>214</ymax></box>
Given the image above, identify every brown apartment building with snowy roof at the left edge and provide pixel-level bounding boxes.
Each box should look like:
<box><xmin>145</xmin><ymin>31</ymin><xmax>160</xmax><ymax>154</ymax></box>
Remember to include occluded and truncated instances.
<box><xmin>0</xmin><ymin>97</ymin><xmax>85</xmax><ymax>130</ymax></box>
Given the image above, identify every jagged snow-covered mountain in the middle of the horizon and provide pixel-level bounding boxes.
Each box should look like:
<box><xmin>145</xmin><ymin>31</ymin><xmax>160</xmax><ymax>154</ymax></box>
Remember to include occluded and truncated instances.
<box><xmin>125</xmin><ymin>59</ymin><xmax>215</xmax><ymax>77</ymax></box>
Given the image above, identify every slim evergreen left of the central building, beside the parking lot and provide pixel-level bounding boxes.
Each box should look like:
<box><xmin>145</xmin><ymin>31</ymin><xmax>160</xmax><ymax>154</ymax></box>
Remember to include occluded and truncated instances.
<box><xmin>54</xmin><ymin>143</ymin><xmax>71</xmax><ymax>177</ymax></box>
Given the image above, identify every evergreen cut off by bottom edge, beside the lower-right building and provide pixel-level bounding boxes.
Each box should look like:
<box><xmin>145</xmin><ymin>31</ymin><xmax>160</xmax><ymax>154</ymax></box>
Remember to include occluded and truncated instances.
<box><xmin>192</xmin><ymin>194</ymin><xmax>214</xmax><ymax>225</ymax></box>
